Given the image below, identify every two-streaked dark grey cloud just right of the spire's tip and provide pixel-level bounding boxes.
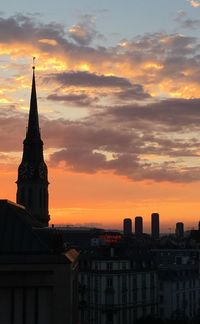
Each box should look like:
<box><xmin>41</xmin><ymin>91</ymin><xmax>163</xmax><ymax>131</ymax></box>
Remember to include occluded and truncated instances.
<box><xmin>44</xmin><ymin>71</ymin><xmax>151</xmax><ymax>106</ymax></box>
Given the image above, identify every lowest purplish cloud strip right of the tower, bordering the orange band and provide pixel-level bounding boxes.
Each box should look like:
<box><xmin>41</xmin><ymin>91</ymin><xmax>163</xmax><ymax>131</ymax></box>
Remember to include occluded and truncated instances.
<box><xmin>51</xmin><ymin>148</ymin><xmax>200</xmax><ymax>182</ymax></box>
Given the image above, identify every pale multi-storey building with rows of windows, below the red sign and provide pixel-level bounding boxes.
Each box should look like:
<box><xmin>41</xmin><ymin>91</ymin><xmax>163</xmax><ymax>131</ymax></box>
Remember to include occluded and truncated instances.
<box><xmin>79</xmin><ymin>242</ymin><xmax>158</xmax><ymax>324</ymax></box>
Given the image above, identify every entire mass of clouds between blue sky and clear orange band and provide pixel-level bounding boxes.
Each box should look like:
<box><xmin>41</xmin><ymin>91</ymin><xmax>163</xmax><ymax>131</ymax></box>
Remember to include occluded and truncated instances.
<box><xmin>0</xmin><ymin>15</ymin><xmax>200</xmax><ymax>182</ymax></box>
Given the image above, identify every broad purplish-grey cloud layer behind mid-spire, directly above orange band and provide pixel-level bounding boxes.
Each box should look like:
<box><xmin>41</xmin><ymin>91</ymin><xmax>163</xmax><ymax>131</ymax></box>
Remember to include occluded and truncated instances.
<box><xmin>0</xmin><ymin>99</ymin><xmax>200</xmax><ymax>182</ymax></box>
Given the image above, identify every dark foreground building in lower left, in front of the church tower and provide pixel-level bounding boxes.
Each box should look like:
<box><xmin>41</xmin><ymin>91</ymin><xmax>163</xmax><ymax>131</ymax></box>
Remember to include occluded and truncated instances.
<box><xmin>0</xmin><ymin>200</ymin><xmax>78</xmax><ymax>324</ymax></box>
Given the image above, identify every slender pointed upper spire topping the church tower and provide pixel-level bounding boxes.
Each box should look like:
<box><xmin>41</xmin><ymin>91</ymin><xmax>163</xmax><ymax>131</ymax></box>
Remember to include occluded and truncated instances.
<box><xmin>27</xmin><ymin>58</ymin><xmax>40</xmax><ymax>139</ymax></box>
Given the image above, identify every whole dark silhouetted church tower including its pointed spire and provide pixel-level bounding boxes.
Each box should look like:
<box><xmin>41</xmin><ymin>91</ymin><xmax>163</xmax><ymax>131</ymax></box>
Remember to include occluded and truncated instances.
<box><xmin>17</xmin><ymin>62</ymin><xmax>50</xmax><ymax>227</ymax></box>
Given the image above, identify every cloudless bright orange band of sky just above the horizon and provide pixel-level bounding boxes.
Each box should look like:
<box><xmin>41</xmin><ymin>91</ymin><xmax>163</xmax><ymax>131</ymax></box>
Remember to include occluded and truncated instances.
<box><xmin>0</xmin><ymin>168</ymin><xmax>200</xmax><ymax>232</ymax></box>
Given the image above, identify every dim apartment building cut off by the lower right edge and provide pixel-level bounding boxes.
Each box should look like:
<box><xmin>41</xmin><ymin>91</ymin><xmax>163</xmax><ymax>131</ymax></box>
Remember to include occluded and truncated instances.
<box><xmin>153</xmin><ymin>247</ymin><xmax>200</xmax><ymax>320</ymax></box>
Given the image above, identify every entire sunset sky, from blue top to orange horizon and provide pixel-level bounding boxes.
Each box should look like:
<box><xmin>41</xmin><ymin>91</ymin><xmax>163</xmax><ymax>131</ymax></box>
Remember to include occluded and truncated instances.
<box><xmin>0</xmin><ymin>0</ymin><xmax>200</xmax><ymax>231</ymax></box>
